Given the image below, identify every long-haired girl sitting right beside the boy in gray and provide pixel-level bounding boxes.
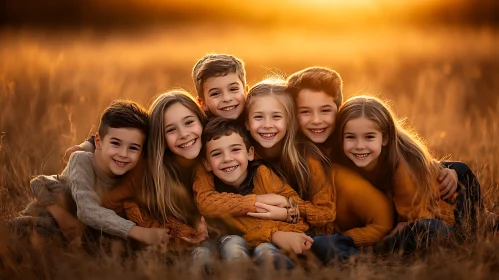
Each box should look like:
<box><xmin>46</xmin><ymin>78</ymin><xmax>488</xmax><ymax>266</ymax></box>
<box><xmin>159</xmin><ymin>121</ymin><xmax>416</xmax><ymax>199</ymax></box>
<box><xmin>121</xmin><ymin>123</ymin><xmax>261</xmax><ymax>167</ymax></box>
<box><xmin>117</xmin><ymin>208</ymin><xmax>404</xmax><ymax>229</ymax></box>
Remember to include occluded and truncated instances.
<box><xmin>67</xmin><ymin>90</ymin><xmax>208</xmax><ymax>245</ymax></box>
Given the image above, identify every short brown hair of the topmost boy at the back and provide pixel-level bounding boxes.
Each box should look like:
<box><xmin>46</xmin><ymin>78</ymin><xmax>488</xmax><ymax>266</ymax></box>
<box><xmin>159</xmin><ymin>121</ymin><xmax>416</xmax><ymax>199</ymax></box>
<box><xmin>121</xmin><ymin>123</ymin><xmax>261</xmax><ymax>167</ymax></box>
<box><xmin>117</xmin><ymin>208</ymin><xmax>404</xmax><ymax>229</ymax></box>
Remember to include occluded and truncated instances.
<box><xmin>192</xmin><ymin>54</ymin><xmax>246</xmax><ymax>100</ymax></box>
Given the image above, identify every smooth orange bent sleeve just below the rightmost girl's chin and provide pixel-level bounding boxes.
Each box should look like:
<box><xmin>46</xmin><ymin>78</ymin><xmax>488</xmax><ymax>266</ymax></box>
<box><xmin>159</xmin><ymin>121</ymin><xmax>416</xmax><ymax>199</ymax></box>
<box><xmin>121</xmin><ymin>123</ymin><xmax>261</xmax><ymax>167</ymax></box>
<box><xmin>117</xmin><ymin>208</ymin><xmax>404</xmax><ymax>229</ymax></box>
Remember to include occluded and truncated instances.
<box><xmin>332</xmin><ymin>165</ymin><xmax>395</xmax><ymax>247</ymax></box>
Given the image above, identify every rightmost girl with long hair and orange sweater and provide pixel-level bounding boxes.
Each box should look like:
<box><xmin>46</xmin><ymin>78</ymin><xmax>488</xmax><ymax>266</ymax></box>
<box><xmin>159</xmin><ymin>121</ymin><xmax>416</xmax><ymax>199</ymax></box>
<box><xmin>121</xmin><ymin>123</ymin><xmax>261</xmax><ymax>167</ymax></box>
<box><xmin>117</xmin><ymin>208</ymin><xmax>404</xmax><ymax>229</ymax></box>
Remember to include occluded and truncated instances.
<box><xmin>337</xmin><ymin>96</ymin><xmax>468</xmax><ymax>251</ymax></box>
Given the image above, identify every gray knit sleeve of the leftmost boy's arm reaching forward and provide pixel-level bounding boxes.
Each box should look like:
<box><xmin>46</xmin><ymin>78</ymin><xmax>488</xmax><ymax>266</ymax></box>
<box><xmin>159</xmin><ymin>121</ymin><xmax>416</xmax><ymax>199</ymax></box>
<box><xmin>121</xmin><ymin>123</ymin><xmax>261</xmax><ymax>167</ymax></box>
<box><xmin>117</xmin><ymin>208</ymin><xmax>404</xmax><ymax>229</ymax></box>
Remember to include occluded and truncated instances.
<box><xmin>65</xmin><ymin>152</ymin><xmax>135</xmax><ymax>239</ymax></box>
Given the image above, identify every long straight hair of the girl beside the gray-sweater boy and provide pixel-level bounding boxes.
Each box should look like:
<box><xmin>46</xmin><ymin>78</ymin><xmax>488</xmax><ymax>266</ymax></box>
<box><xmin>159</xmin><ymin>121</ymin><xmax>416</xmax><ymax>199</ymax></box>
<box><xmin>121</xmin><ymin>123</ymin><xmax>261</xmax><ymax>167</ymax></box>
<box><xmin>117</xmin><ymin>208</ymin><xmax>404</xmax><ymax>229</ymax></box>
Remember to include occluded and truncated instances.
<box><xmin>142</xmin><ymin>90</ymin><xmax>206</xmax><ymax>222</ymax></box>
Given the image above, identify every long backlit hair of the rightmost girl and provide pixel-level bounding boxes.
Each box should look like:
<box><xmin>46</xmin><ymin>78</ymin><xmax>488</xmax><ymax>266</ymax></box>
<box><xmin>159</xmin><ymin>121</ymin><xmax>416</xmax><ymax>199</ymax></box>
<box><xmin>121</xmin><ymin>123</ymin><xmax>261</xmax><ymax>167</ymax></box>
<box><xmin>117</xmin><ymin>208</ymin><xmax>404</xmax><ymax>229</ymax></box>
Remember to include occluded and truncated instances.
<box><xmin>336</xmin><ymin>96</ymin><xmax>442</xmax><ymax>199</ymax></box>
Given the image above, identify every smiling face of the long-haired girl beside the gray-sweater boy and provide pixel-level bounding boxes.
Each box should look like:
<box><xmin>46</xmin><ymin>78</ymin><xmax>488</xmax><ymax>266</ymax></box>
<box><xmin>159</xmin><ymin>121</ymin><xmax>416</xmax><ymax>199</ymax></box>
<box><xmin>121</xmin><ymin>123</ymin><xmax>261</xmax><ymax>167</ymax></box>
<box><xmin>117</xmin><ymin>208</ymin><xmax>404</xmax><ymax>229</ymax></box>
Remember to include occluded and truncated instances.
<box><xmin>164</xmin><ymin>103</ymin><xmax>203</xmax><ymax>160</ymax></box>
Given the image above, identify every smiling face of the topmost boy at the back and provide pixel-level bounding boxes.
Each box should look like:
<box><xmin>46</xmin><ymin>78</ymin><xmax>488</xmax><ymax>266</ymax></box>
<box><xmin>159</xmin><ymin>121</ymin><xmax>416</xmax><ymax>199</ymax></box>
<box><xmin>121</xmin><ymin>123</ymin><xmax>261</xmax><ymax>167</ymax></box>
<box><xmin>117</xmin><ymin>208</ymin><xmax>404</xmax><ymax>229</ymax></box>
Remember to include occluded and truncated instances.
<box><xmin>198</xmin><ymin>73</ymin><xmax>246</xmax><ymax>119</ymax></box>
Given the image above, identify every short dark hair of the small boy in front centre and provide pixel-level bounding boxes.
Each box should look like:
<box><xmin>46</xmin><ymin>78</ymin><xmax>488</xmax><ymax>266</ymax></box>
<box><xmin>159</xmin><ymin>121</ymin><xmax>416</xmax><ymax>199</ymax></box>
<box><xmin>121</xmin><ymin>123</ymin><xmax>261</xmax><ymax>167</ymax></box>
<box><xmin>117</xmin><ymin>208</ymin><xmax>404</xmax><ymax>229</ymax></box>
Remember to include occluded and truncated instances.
<box><xmin>201</xmin><ymin>117</ymin><xmax>251</xmax><ymax>156</ymax></box>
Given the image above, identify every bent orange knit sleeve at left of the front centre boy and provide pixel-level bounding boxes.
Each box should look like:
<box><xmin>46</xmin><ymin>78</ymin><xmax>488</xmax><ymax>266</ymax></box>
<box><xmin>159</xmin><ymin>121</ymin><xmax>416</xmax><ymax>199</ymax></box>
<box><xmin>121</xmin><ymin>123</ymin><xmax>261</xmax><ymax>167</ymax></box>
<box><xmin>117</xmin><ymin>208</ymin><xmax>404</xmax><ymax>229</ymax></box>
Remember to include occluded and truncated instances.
<box><xmin>192</xmin><ymin>164</ymin><xmax>257</xmax><ymax>217</ymax></box>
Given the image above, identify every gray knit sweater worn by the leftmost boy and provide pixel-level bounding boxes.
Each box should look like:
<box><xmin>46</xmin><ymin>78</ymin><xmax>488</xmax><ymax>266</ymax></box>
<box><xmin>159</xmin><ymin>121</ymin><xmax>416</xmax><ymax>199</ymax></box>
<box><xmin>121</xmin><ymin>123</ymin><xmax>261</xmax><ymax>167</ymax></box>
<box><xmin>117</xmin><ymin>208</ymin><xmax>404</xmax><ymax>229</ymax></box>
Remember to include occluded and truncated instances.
<box><xmin>31</xmin><ymin>151</ymin><xmax>135</xmax><ymax>239</ymax></box>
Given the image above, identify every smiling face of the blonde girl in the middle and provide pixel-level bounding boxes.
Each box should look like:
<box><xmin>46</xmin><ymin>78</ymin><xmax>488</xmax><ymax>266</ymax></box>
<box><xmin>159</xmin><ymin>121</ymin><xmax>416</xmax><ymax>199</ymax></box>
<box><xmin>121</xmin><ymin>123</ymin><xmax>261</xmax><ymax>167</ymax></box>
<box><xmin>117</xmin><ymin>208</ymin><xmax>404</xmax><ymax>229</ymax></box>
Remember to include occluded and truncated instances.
<box><xmin>246</xmin><ymin>96</ymin><xmax>287</xmax><ymax>149</ymax></box>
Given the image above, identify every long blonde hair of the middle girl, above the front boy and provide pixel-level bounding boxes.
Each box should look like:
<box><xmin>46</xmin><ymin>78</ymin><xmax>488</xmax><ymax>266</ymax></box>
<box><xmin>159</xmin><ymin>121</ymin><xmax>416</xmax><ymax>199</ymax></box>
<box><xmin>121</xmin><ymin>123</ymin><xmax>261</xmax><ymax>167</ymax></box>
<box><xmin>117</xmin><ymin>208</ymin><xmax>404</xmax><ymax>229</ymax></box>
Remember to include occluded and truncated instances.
<box><xmin>246</xmin><ymin>78</ymin><xmax>327</xmax><ymax>197</ymax></box>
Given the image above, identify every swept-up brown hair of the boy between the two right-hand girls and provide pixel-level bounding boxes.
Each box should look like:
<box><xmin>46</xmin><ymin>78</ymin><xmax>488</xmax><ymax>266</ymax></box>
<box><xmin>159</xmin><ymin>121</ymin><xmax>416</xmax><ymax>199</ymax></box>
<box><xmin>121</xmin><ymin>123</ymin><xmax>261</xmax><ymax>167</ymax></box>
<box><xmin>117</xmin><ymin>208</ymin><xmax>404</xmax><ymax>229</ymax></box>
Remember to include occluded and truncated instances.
<box><xmin>287</xmin><ymin>66</ymin><xmax>343</xmax><ymax>108</ymax></box>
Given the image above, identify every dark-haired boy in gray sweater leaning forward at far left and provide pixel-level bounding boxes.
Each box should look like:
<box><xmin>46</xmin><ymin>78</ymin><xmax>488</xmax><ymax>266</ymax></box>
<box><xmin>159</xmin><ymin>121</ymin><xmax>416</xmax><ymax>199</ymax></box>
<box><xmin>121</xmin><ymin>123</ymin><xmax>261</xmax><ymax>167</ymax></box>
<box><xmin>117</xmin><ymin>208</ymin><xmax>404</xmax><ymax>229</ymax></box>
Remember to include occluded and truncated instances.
<box><xmin>14</xmin><ymin>100</ymin><xmax>169</xmax><ymax>245</ymax></box>
